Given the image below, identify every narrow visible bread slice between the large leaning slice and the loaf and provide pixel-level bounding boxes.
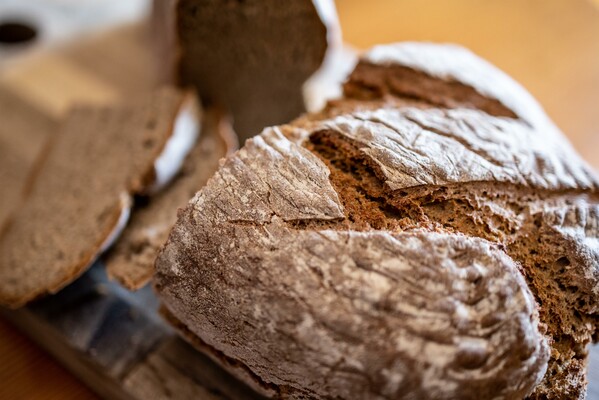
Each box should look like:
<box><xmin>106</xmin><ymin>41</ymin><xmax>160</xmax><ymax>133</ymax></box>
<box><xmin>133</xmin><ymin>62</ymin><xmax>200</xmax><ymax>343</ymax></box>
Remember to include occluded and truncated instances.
<box><xmin>105</xmin><ymin>109</ymin><xmax>237</xmax><ymax>290</ymax></box>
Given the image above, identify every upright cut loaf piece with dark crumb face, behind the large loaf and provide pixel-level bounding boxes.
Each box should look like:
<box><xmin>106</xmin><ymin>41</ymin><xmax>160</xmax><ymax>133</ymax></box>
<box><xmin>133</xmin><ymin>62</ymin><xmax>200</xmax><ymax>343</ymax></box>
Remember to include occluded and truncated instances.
<box><xmin>153</xmin><ymin>0</ymin><xmax>340</xmax><ymax>138</ymax></box>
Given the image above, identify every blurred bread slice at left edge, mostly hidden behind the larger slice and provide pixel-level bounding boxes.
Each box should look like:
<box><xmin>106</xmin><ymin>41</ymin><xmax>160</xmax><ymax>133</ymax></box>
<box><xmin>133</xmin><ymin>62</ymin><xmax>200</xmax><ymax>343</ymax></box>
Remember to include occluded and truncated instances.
<box><xmin>0</xmin><ymin>88</ymin><xmax>58</xmax><ymax>230</ymax></box>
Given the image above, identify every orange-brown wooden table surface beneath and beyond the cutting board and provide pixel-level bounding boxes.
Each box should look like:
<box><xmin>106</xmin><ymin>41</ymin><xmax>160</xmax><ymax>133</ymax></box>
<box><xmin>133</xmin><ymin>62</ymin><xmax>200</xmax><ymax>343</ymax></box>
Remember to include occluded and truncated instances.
<box><xmin>0</xmin><ymin>0</ymin><xmax>599</xmax><ymax>400</ymax></box>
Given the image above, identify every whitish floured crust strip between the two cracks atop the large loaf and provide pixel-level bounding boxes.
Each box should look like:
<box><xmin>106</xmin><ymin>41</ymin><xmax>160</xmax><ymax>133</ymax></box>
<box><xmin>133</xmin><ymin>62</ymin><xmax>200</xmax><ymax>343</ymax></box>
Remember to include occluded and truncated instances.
<box><xmin>317</xmin><ymin>107</ymin><xmax>598</xmax><ymax>190</ymax></box>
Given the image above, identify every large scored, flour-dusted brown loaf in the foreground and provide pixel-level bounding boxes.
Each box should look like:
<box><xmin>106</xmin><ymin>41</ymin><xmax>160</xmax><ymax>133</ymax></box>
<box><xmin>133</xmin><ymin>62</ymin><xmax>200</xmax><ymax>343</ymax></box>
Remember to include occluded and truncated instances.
<box><xmin>155</xmin><ymin>43</ymin><xmax>599</xmax><ymax>399</ymax></box>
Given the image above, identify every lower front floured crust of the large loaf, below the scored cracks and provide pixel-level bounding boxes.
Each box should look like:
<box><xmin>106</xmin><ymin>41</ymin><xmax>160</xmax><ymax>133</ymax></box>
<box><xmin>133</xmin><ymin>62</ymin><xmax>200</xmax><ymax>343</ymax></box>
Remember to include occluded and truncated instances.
<box><xmin>158</xmin><ymin>208</ymin><xmax>548</xmax><ymax>399</ymax></box>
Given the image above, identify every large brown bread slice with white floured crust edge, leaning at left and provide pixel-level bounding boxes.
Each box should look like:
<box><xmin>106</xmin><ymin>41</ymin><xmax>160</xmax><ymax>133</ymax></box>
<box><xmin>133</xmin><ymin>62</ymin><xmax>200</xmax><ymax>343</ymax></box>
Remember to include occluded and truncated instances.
<box><xmin>0</xmin><ymin>89</ymin><xmax>198</xmax><ymax>307</ymax></box>
